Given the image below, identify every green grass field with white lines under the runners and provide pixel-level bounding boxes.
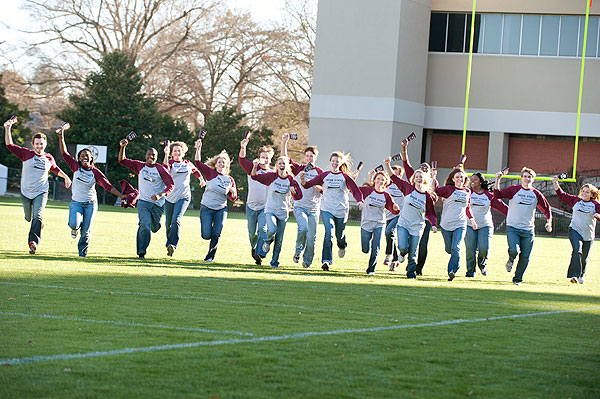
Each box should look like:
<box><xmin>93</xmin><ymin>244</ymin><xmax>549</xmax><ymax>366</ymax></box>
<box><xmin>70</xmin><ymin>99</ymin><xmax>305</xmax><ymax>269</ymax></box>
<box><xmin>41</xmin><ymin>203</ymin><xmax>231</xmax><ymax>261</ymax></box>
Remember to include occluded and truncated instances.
<box><xmin>0</xmin><ymin>198</ymin><xmax>600</xmax><ymax>399</ymax></box>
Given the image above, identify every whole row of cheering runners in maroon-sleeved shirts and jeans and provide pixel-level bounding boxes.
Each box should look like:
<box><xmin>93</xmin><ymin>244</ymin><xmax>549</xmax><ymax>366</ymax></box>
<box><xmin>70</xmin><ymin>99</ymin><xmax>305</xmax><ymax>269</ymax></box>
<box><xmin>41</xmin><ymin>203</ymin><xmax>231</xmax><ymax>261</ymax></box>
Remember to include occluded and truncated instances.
<box><xmin>4</xmin><ymin>118</ymin><xmax>600</xmax><ymax>284</ymax></box>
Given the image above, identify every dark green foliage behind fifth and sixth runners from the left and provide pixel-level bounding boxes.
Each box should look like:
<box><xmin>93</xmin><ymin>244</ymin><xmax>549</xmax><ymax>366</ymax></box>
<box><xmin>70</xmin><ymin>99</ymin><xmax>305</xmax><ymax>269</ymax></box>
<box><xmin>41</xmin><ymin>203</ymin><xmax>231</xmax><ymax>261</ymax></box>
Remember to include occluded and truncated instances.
<box><xmin>194</xmin><ymin>107</ymin><xmax>279</xmax><ymax>206</ymax></box>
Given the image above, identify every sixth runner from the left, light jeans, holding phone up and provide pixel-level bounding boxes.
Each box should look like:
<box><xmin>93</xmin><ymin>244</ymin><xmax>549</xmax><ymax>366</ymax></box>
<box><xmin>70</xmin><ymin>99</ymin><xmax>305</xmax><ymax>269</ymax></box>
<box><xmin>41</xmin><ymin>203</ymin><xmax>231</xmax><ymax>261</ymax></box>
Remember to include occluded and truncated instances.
<box><xmin>238</xmin><ymin>138</ymin><xmax>274</xmax><ymax>265</ymax></box>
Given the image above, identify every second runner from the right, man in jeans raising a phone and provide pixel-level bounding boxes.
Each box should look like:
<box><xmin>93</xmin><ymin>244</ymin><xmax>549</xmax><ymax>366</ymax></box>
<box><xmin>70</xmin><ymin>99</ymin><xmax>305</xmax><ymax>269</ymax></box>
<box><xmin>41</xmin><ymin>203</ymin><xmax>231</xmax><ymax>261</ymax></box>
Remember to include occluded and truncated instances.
<box><xmin>494</xmin><ymin>167</ymin><xmax>552</xmax><ymax>285</ymax></box>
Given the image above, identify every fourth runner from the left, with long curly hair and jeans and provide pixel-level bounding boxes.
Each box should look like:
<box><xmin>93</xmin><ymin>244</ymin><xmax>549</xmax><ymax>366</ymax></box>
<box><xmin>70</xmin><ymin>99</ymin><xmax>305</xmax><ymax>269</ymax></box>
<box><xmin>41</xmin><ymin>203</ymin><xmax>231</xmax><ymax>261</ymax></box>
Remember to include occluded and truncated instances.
<box><xmin>163</xmin><ymin>141</ymin><xmax>206</xmax><ymax>256</ymax></box>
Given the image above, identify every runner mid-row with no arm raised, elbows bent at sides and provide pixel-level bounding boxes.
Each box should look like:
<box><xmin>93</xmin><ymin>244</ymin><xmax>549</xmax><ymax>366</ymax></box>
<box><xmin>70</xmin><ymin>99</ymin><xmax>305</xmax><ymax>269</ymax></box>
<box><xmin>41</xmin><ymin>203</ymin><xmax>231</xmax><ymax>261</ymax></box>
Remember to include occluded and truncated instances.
<box><xmin>359</xmin><ymin>171</ymin><xmax>400</xmax><ymax>276</ymax></box>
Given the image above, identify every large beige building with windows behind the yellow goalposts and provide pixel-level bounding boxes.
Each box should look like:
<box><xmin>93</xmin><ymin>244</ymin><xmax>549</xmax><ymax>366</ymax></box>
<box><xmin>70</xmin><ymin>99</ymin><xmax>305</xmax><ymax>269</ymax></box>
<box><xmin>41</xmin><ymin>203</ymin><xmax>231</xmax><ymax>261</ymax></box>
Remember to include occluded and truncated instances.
<box><xmin>309</xmin><ymin>0</ymin><xmax>600</xmax><ymax>182</ymax></box>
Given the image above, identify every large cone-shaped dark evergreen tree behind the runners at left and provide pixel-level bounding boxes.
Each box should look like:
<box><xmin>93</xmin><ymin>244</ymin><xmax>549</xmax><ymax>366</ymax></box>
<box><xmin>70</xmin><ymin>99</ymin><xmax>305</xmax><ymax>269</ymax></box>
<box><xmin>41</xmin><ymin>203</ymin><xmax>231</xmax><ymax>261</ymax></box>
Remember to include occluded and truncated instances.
<box><xmin>57</xmin><ymin>51</ymin><xmax>194</xmax><ymax>198</ymax></box>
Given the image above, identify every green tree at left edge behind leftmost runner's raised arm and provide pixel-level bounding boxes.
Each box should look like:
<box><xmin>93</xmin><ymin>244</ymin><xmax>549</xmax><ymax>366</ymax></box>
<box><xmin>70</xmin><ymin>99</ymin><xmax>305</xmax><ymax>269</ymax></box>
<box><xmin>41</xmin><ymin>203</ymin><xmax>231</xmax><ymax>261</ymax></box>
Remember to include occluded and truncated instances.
<box><xmin>0</xmin><ymin>75</ymin><xmax>31</xmax><ymax>168</ymax></box>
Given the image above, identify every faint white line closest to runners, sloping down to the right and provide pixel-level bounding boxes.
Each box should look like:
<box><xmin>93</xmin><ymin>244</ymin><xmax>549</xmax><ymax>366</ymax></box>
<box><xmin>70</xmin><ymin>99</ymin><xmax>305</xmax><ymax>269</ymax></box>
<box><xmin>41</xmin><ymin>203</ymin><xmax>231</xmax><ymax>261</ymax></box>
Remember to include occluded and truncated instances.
<box><xmin>0</xmin><ymin>281</ymin><xmax>436</xmax><ymax>320</ymax></box>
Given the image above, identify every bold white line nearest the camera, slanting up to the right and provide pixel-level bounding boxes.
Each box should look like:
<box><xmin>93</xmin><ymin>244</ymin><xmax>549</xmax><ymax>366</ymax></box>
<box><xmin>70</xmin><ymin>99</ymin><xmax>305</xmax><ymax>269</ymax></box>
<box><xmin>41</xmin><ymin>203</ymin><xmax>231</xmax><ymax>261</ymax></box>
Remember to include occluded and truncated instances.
<box><xmin>0</xmin><ymin>306</ymin><xmax>600</xmax><ymax>365</ymax></box>
